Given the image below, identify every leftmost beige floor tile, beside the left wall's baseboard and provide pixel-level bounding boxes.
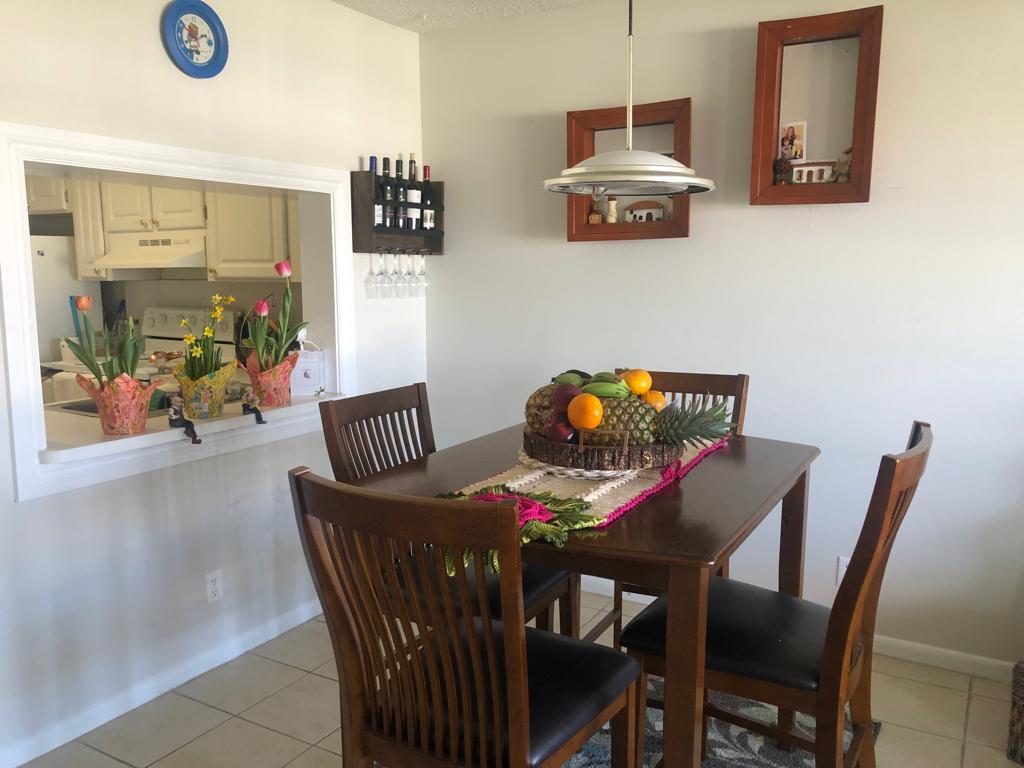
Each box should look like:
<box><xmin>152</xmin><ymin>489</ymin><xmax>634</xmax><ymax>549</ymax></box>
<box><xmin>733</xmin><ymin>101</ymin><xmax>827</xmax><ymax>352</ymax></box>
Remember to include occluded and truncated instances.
<box><xmin>81</xmin><ymin>693</ymin><xmax>230</xmax><ymax>766</ymax></box>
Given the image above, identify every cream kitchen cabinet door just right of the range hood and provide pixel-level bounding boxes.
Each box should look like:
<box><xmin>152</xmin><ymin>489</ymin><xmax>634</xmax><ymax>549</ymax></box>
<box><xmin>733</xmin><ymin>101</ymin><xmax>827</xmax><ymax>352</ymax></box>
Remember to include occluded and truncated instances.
<box><xmin>206</xmin><ymin>190</ymin><xmax>298</xmax><ymax>281</ymax></box>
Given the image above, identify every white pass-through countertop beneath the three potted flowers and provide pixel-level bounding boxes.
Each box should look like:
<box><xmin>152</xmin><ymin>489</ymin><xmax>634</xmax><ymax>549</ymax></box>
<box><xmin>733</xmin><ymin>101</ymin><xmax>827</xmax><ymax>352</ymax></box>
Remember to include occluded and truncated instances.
<box><xmin>39</xmin><ymin>394</ymin><xmax>343</xmax><ymax>464</ymax></box>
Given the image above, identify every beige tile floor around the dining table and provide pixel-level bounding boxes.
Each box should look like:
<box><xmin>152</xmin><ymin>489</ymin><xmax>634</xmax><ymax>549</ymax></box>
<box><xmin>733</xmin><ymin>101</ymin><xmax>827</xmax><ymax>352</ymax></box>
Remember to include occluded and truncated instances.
<box><xmin>25</xmin><ymin>593</ymin><xmax>1017</xmax><ymax>768</ymax></box>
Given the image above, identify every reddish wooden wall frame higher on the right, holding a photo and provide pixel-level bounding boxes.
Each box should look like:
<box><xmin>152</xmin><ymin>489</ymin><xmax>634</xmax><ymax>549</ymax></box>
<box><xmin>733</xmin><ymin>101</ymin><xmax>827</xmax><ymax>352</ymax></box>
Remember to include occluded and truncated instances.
<box><xmin>751</xmin><ymin>5</ymin><xmax>882</xmax><ymax>205</ymax></box>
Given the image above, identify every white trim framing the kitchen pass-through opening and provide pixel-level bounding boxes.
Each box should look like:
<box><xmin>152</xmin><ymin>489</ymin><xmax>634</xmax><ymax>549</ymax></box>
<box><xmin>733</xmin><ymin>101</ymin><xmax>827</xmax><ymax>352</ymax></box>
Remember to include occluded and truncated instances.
<box><xmin>0</xmin><ymin>122</ymin><xmax>356</xmax><ymax>501</ymax></box>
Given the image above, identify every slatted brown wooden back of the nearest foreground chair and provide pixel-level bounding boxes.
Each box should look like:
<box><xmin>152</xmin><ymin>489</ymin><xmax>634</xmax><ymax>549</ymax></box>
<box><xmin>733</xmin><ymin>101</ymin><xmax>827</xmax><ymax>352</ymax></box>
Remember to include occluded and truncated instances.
<box><xmin>290</xmin><ymin>467</ymin><xmax>528</xmax><ymax>768</ymax></box>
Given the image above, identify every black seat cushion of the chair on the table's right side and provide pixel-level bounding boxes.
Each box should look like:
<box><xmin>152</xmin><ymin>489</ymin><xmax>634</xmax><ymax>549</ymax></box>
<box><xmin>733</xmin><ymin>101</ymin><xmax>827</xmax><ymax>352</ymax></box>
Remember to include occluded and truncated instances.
<box><xmin>622</xmin><ymin>577</ymin><xmax>829</xmax><ymax>691</ymax></box>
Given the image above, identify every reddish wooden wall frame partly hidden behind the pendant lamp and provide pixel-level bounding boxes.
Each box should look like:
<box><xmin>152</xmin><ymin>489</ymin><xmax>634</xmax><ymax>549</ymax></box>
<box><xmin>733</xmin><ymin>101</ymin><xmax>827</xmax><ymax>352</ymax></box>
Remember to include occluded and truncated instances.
<box><xmin>565</xmin><ymin>98</ymin><xmax>690</xmax><ymax>241</ymax></box>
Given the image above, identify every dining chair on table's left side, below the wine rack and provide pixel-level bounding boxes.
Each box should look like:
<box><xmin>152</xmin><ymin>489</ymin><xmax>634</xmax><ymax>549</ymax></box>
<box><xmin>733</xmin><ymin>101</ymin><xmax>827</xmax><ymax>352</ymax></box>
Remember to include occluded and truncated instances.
<box><xmin>319</xmin><ymin>382</ymin><xmax>581</xmax><ymax>637</ymax></box>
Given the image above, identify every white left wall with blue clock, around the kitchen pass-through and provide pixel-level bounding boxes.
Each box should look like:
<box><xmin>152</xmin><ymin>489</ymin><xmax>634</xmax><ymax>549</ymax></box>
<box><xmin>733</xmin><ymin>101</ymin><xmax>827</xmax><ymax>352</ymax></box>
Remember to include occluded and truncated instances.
<box><xmin>0</xmin><ymin>0</ymin><xmax>424</xmax><ymax>766</ymax></box>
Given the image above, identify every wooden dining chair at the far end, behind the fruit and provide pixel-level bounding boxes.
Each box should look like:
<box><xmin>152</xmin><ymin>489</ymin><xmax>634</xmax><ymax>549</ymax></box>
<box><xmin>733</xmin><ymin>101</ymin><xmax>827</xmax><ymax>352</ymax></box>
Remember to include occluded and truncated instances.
<box><xmin>587</xmin><ymin>369</ymin><xmax>751</xmax><ymax>648</ymax></box>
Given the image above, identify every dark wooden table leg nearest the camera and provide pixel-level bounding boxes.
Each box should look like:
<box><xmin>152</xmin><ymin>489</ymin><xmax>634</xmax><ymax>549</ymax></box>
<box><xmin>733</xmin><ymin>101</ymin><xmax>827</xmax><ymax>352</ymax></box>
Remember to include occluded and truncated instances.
<box><xmin>663</xmin><ymin>566</ymin><xmax>709</xmax><ymax>768</ymax></box>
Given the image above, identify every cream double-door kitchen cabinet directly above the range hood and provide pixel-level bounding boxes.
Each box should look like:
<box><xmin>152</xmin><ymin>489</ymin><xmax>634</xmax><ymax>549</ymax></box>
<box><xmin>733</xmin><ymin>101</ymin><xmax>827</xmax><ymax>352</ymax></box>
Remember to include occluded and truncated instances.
<box><xmin>99</xmin><ymin>181</ymin><xmax>206</xmax><ymax>232</ymax></box>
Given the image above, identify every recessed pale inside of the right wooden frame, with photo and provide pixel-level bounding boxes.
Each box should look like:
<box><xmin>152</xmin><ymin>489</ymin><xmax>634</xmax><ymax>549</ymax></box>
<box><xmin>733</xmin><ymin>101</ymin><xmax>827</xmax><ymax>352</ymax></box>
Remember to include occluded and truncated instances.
<box><xmin>772</xmin><ymin>38</ymin><xmax>859</xmax><ymax>184</ymax></box>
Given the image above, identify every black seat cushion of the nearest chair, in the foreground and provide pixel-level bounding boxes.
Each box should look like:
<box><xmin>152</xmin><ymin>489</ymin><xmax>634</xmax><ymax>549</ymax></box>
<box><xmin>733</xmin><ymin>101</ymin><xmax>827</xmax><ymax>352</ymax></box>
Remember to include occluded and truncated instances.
<box><xmin>421</xmin><ymin>618</ymin><xmax>640</xmax><ymax>766</ymax></box>
